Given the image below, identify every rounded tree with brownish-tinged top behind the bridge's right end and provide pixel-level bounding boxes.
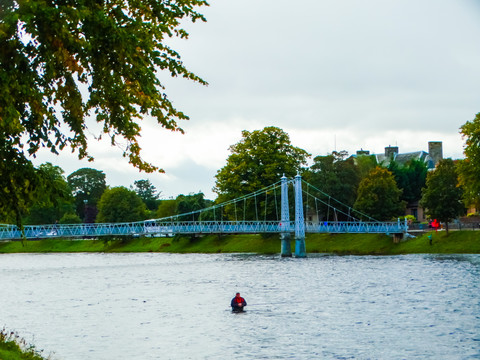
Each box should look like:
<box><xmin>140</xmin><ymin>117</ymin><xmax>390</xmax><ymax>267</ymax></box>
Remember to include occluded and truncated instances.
<box><xmin>353</xmin><ymin>167</ymin><xmax>405</xmax><ymax>221</ymax></box>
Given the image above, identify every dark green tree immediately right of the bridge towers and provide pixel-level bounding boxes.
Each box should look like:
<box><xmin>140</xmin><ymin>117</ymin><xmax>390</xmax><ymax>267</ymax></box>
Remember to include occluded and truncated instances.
<box><xmin>304</xmin><ymin>151</ymin><xmax>360</xmax><ymax>220</ymax></box>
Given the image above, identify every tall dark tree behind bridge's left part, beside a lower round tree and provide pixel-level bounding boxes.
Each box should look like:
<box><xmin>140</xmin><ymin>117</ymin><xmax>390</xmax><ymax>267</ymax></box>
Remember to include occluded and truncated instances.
<box><xmin>67</xmin><ymin>168</ymin><xmax>107</xmax><ymax>223</ymax></box>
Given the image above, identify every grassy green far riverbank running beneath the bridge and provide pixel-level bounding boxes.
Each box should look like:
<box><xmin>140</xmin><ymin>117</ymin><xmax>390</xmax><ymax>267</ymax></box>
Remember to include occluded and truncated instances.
<box><xmin>0</xmin><ymin>231</ymin><xmax>480</xmax><ymax>255</ymax></box>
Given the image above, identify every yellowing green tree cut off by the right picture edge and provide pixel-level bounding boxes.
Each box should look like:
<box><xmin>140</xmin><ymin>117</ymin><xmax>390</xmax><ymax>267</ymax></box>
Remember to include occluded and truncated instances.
<box><xmin>458</xmin><ymin>113</ymin><xmax>480</xmax><ymax>209</ymax></box>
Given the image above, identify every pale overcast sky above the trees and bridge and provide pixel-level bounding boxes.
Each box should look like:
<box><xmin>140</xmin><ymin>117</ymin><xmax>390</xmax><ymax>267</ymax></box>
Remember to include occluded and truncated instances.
<box><xmin>35</xmin><ymin>0</ymin><xmax>480</xmax><ymax>199</ymax></box>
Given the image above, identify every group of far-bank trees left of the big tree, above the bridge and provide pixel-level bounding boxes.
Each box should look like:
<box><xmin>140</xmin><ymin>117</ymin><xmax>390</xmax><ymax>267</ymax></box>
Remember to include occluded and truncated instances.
<box><xmin>0</xmin><ymin>163</ymin><xmax>211</xmax><ymax>225</ymax></box>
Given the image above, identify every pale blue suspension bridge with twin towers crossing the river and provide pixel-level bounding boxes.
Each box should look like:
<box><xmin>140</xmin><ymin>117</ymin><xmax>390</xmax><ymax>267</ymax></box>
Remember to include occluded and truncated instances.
<box><xmin>0</xmin><ymin>175</ymin><xmax>408</xmax><ymax>257</ymax></box>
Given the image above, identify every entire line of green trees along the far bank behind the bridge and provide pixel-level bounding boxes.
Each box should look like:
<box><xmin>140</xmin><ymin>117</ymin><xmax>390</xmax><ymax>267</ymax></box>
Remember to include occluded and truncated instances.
<box><xmin>4</xmin><ymin>114</ymin><xmax>480</xmax><ymax>228</ymax></box>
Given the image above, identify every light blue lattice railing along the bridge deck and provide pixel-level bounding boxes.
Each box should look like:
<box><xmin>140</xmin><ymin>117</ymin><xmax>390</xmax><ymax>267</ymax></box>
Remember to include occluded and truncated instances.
<box><xmin>0</xmin><ymin>220</ymin><xmax>407</xmax><ymax>240</ymax></box>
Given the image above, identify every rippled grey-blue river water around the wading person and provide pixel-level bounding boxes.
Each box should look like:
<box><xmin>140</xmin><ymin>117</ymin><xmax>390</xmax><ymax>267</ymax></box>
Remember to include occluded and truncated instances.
<box><xmin>0</xmin><ymin>253</ymin><xmax>480</xmax><ymax>360</ymax></box>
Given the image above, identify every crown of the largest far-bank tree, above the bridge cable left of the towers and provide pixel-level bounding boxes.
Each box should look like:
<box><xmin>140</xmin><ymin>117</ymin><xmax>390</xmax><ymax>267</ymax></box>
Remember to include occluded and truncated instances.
<box><xmin>214</xmin><ymin>126</ymin><xmax>310</xmax><ymax>201</ymax></box>
